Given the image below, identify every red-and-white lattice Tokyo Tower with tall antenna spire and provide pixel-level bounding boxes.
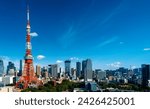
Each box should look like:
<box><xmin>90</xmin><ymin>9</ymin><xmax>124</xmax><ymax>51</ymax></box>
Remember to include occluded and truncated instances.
<box><xmin>16</xmin><ymin>3</ymin><xmax>42</xmax><ymax>89</ymax></box>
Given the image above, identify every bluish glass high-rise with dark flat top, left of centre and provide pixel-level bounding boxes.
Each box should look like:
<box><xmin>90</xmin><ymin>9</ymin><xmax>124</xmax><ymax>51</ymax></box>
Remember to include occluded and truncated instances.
<box><xmin>65</xmin><ymin>60</ymin><xmax>72</xmax><ymax>78</ymax></box>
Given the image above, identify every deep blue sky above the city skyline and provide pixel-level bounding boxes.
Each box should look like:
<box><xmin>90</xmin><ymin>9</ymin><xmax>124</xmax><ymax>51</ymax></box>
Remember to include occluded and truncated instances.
<box><xmin>0</xmin><ymin>0</ymin><xmax>150</xmax><ymax>69</ymax></box>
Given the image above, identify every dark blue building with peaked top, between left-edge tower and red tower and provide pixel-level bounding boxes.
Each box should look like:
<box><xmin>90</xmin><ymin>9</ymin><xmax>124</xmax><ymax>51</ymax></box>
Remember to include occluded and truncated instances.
<box><xmin>7</xmin><ymin>62</ymin><xmax>16</xmax><ymax>75</ymax></box>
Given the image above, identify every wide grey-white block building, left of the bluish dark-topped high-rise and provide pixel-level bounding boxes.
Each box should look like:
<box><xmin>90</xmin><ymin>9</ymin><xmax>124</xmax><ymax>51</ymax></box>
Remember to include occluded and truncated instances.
<box><xmin>49</xmin><ymin>64</ymin><xmax>59</xmax><ymax>79</ymax></box>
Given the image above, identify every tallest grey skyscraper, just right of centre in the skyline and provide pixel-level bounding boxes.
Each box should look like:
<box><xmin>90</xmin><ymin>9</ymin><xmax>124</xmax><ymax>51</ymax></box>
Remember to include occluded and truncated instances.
<box><xmin>84</xmin><ymin>59</ymin><xmax>93</xmax><ymax>82</ymax></box>
